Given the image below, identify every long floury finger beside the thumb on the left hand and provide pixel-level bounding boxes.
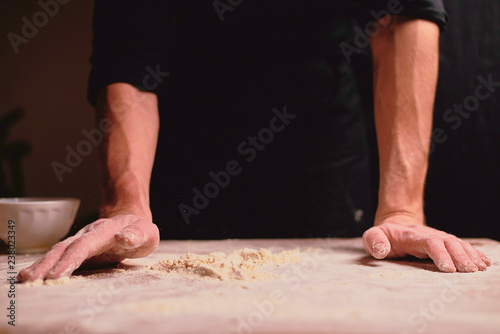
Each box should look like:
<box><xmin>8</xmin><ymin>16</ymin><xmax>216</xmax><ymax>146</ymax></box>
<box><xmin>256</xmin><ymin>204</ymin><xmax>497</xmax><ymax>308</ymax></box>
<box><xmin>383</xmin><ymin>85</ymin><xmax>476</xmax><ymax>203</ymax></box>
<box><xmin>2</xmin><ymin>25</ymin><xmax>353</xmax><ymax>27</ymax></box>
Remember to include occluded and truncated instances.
<box><xmin>46</xmin><ymin>219</ymin><xmax>117</xmax><ymax>279</ymax></box>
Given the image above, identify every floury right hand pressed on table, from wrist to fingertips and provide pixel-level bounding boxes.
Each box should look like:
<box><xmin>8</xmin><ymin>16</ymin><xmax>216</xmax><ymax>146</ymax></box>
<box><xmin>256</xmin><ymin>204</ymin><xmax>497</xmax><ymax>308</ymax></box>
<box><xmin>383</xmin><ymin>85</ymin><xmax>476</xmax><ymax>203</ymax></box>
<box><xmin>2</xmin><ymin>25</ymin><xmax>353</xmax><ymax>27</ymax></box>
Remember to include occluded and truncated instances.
<box><xmin>363</xmin><ymin>214</ymin><xmax>491</xmax><ymax>273</ymax></box>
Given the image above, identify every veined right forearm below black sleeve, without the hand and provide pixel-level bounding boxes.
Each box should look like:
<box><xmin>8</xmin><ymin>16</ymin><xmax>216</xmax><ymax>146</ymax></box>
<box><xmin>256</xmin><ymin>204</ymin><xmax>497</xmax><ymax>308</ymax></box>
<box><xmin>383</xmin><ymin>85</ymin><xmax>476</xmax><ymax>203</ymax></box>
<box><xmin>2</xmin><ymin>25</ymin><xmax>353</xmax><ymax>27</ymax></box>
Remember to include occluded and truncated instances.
<box><xmin>371</xmin><ymin>17</ymin><xmax>439</xmax><ymax>225</ymax></box>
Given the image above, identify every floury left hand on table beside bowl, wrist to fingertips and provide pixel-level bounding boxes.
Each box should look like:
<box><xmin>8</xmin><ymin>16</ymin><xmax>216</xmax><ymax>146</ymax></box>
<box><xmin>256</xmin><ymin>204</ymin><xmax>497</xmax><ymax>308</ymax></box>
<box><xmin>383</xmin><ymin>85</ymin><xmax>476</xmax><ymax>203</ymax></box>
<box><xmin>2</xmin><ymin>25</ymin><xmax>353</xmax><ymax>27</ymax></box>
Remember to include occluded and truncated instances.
<box><xmin>17</xmin><ymin>214</ymin><xmax>160</xmax><ymax>282</ymax></box>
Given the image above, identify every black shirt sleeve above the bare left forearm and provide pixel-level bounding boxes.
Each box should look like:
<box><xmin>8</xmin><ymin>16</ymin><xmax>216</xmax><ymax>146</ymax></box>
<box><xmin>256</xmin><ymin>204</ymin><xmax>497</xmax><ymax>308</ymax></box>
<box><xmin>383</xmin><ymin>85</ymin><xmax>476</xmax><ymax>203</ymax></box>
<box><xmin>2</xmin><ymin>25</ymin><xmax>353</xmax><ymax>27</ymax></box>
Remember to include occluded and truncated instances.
<box><xmin>87</xmin><ymin>0</ymin><xmax>172</xmax><ymax>106</ymax></box>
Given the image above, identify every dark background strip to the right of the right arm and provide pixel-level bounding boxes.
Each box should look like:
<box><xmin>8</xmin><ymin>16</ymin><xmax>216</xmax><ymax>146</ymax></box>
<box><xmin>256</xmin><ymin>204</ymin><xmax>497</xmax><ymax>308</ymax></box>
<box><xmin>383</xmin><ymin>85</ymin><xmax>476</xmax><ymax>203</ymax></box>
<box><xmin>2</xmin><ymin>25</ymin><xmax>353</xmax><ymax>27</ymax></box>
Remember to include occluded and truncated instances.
<box><xmin>427</xmin><ymin>1</ymin><xmax>500</xmax><ymax>240</ymax></box>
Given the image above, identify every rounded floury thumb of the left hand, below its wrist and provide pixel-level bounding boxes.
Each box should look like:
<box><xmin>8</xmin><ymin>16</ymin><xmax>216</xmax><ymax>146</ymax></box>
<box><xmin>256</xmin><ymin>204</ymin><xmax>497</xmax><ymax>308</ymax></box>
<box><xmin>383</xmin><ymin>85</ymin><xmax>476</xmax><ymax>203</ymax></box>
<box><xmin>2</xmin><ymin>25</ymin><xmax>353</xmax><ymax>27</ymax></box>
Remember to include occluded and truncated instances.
<box><xmin>114</xmin><ymin>219</ymin><xmax>159</xmax><ymax>258</ymax></box>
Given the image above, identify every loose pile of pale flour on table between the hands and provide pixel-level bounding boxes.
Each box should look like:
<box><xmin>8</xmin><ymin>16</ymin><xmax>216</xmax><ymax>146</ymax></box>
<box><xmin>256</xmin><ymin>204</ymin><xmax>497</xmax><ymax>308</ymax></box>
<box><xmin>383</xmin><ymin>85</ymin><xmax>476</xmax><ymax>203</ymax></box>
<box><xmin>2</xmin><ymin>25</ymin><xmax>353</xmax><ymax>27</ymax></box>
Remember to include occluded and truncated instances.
<box><xmin>151</xmin><ymin>248</ymin><xmax>303</xmax><ymax>281</ymax></box>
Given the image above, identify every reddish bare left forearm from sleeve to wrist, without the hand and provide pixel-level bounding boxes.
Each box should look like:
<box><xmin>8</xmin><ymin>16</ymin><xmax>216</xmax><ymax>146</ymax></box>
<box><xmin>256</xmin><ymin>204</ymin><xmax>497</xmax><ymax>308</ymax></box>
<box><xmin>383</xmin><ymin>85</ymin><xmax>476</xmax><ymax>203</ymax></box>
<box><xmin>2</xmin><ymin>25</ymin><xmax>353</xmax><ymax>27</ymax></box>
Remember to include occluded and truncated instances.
<box><xmin>97</xmin><ymin>83</ymin><xmax>159</xmax><ymax>220</ymax></box>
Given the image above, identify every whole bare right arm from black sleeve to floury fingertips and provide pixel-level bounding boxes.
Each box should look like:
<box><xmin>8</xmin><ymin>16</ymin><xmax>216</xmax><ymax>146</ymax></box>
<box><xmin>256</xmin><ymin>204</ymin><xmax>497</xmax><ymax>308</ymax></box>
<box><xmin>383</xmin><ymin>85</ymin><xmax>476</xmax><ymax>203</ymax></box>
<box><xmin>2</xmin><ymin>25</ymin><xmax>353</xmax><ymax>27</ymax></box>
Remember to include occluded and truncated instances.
<box><xmin>363</xmin><ymin>17</ymin><xmax>491</xmax><ymax>272</ymax></box>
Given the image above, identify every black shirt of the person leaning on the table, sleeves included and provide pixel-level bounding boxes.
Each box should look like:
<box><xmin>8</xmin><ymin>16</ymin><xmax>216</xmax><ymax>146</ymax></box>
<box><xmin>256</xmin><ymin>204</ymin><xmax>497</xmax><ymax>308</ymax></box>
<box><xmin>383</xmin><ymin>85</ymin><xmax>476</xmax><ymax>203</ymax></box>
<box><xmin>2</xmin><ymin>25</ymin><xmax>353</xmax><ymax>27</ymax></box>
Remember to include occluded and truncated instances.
<box><xmin>89</xmin><ymin>0</ymin><xmax>446</xmax><ymax>238</ymax></box>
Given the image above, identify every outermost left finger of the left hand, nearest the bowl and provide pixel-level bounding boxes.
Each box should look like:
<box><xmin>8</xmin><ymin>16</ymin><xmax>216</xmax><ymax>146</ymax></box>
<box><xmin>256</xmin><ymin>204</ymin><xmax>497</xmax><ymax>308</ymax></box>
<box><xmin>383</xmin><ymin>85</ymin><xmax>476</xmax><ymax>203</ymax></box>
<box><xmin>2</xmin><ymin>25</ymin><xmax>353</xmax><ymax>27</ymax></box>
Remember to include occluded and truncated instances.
<box><xmin>17</xmin><ymin>231</ymin><xmax>83</xmax><ymax>282</ymax></box>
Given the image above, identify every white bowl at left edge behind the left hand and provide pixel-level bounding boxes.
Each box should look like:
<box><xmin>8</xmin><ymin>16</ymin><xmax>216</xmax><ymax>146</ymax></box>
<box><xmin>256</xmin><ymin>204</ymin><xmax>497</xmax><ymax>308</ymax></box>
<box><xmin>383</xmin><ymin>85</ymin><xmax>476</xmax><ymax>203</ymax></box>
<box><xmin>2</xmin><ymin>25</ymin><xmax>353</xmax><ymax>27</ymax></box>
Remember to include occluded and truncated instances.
<box><xmin>0</xmin><ymin>197</ymin><xmax>80</xmax><ymax>253</ymax></box>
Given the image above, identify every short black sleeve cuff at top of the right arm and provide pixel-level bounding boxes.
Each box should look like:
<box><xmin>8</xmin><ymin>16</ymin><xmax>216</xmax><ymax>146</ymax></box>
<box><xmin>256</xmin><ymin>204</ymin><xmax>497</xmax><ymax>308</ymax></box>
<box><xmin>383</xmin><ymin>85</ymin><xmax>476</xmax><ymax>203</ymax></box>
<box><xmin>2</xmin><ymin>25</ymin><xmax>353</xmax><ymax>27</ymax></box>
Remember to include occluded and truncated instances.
<box><xmin>353</xmin><ymin>0</ymin><xmax>448</xmax><ymax>31</ymax></box>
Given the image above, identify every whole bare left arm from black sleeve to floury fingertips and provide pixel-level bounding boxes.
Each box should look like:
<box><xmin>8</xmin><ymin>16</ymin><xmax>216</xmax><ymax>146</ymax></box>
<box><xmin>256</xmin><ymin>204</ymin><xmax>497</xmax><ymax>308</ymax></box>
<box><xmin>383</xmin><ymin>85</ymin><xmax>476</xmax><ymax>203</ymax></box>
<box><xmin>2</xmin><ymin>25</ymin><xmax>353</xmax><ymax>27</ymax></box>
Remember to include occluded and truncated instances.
<box><xmin>18</xmin><ymin>83</ymin><xmax>159</xmax><ymax>281</ymax></box>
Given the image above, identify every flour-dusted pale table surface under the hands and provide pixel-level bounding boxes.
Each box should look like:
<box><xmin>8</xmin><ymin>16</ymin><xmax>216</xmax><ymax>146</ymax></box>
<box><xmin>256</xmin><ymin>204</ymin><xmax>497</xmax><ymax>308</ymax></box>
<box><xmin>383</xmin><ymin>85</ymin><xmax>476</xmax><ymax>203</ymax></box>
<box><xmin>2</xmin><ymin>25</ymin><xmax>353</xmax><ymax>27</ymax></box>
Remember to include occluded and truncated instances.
<box><xmin>0</xmin><ymin>239</ymin><xmax>500</xmax><ymax>334</ymax></box>
